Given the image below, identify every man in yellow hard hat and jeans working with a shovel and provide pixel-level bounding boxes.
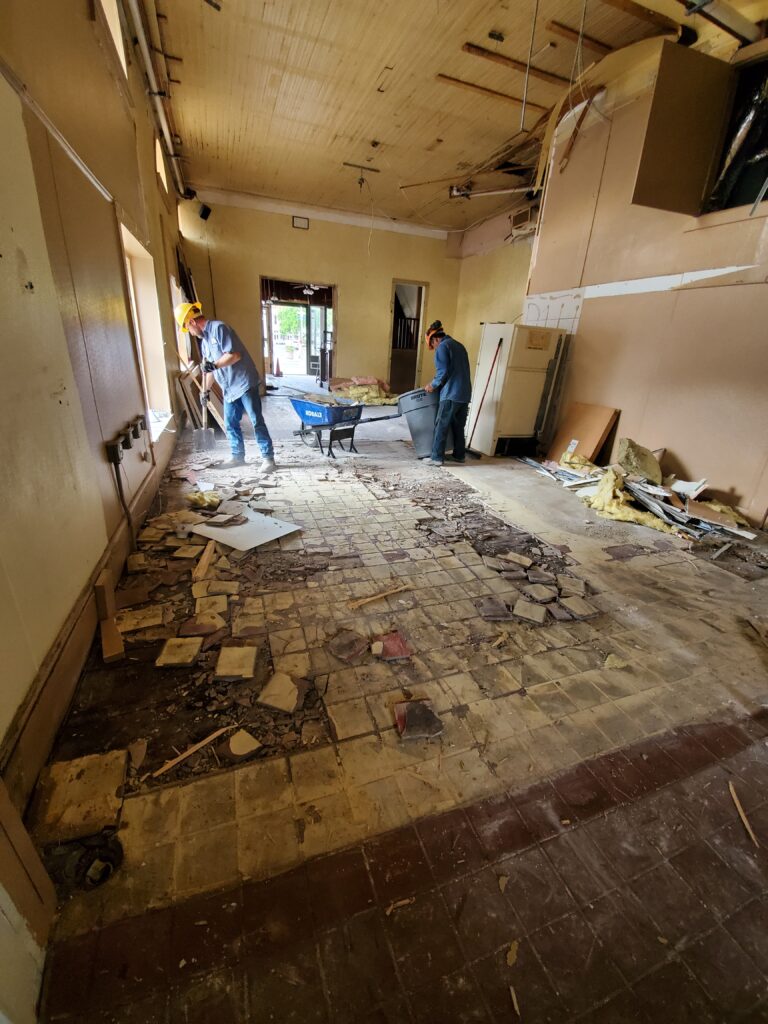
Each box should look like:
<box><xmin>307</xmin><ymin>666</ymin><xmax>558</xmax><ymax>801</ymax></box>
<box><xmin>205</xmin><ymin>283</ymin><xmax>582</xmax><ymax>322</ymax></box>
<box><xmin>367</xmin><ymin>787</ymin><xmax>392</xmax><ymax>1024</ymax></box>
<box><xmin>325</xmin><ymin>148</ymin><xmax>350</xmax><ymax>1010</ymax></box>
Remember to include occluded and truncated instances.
<box><xmin>174</xmin><ymin>302</ymin><xmax>275</xmax><ymax>473</ymax></box>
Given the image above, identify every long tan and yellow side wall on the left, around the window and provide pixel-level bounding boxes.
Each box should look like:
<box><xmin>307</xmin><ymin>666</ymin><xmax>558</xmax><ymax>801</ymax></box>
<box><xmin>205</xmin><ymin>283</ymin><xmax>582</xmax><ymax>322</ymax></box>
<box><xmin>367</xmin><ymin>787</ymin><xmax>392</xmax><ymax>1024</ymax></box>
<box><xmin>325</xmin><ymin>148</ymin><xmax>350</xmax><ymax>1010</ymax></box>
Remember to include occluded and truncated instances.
<box><xmin>0</xmin><ymin>0</ymin><xmax>183</xmax><ymax>806</ymax></box>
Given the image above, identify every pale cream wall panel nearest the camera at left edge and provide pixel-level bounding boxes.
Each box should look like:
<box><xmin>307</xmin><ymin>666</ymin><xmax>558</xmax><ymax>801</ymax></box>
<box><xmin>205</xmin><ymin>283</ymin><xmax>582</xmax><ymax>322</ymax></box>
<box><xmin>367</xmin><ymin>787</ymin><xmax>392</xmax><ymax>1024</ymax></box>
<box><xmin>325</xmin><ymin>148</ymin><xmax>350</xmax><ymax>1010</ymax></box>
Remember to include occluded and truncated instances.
<box><xmin>0</xmin><ymin>79</ymin><xmax>106</xmax><ymax>736</ymax></box>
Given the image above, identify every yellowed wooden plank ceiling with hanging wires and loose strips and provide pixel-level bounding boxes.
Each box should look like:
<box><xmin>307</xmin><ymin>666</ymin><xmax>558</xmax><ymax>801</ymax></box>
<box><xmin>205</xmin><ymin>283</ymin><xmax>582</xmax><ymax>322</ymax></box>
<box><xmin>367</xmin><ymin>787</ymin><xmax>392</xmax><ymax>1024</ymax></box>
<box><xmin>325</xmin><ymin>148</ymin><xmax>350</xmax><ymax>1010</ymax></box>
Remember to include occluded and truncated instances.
<box><xmin>156</xmin><ymin>0</ymin><xmax>658</xmax><ymax>228</ymax></box>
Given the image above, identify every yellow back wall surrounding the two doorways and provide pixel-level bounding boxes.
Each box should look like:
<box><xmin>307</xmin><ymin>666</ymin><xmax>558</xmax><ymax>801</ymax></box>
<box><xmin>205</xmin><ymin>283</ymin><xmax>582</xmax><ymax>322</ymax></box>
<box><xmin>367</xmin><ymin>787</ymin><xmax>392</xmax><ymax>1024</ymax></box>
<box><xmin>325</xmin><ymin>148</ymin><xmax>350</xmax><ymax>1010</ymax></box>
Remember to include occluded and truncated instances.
<box><xmin>181</xmin><ymin>203</ymin><xmax>460</xmax><ymax>382</ymax></box>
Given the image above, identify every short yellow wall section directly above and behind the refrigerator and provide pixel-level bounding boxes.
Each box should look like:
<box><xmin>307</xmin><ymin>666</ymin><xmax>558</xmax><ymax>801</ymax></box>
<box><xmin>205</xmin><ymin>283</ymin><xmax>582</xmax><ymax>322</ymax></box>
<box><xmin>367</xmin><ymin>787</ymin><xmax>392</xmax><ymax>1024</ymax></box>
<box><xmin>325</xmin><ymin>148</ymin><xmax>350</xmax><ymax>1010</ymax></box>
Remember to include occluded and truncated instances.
<box><xmin>445</xmin><ymin>239</ymin><xmax>530</xmax><ymax>373</ymax></box>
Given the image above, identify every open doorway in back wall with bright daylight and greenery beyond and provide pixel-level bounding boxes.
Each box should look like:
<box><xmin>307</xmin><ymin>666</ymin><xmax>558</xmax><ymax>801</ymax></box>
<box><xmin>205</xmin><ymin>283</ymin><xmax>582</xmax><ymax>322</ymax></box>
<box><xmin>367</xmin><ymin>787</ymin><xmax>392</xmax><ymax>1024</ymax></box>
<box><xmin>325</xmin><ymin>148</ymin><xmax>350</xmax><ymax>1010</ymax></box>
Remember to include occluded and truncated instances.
<box><xmin>261</xmin><ymin>278</ymin><xmax>335</xmax><ymax>385</ymax></box>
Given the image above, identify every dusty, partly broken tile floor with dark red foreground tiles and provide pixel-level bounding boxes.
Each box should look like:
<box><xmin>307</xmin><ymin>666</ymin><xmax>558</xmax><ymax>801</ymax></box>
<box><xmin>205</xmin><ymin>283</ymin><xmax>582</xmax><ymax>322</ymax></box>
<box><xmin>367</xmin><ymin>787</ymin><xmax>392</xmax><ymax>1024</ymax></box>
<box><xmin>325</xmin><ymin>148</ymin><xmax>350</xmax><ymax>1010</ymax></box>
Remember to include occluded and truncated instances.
<box><xmin>37</xmin><ymin>398</ymin><xmax>768</xmax><ymax>1024</ymax></box>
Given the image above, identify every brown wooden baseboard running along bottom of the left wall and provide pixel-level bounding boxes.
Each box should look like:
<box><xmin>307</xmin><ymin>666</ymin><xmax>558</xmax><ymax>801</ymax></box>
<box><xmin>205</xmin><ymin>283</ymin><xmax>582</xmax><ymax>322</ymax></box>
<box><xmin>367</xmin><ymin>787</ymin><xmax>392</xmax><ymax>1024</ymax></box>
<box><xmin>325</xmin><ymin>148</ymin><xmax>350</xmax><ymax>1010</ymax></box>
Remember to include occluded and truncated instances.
<box><xmin>0</xmin><ymin>428</ymin><xmax>175</xmax><ymax>813</ymax></box>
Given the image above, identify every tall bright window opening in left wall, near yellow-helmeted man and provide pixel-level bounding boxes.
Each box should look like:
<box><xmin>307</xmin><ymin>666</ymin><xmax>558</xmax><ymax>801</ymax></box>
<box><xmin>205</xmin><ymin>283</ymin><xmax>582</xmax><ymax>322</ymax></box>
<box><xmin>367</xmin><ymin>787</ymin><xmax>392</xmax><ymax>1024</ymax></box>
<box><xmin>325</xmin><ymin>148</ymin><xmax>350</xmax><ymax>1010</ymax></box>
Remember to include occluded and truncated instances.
<box><xmin>120</xmin><ymin>224</ymin><xmax>171</xmax><ymax>441</ymax></box>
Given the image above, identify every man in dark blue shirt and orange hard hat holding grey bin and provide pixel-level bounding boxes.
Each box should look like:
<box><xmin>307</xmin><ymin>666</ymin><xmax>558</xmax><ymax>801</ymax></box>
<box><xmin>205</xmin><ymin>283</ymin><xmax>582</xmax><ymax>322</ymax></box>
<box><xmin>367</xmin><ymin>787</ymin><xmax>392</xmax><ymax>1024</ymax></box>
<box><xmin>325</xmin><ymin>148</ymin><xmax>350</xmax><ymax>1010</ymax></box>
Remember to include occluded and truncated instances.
<box><xmin>424</xmin><ymin>321</ymin><xmax>472</xmax><ymax>466</ymax></box>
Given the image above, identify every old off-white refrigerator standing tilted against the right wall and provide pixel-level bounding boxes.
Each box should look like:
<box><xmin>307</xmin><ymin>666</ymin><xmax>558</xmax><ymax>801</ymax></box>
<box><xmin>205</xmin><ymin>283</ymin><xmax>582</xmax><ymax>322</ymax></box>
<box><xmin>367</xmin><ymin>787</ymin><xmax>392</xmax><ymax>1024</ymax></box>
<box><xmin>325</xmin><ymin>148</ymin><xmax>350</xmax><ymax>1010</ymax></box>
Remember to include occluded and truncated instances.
<box><xmin>467</xmin><ymin>324</ymin><xmax>567</xmax><ymax>455</ymax></box>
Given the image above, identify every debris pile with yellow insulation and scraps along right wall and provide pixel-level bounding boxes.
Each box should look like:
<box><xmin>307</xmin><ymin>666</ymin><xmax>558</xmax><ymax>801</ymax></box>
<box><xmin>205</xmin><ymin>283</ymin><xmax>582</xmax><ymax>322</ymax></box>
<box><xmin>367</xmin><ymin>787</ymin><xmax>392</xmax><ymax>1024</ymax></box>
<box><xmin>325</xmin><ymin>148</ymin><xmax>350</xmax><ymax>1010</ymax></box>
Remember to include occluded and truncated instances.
<box><xmin>521</xmin><ymin>437</ymin><xmax>758</xmax><ymax>542</ymax></box>
